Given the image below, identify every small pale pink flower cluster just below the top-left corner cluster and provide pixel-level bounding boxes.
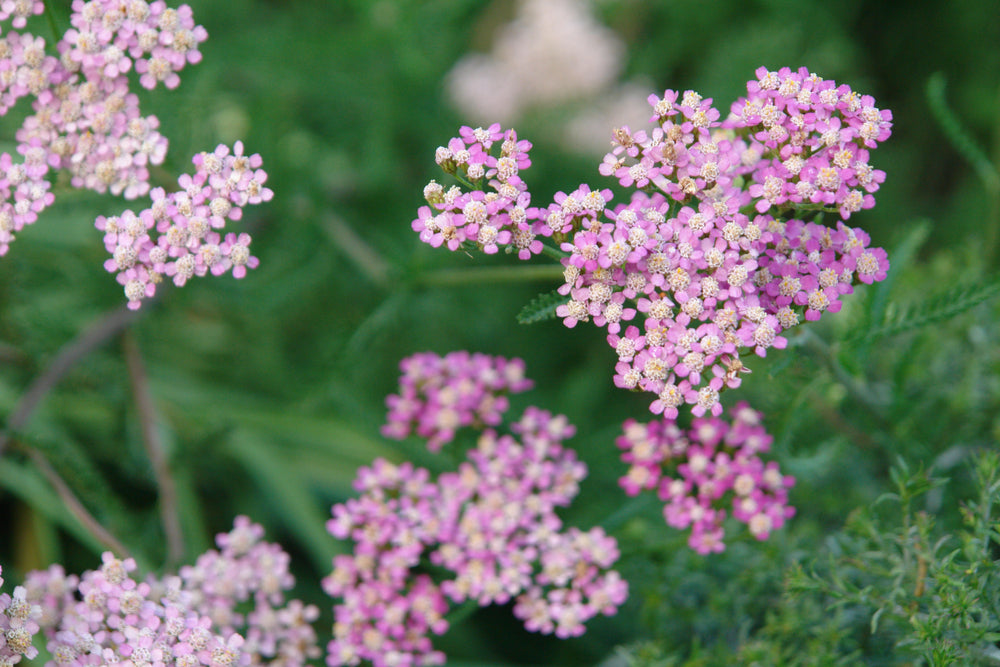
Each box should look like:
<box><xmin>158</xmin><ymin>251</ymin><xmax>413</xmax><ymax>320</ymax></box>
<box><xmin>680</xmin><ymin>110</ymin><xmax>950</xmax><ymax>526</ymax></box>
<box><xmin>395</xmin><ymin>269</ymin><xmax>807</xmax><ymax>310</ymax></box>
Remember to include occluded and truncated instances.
<box><xmin>95</xmin><ymin>141</ymin><xmax>273</xmax><ymax>310</ymax></box>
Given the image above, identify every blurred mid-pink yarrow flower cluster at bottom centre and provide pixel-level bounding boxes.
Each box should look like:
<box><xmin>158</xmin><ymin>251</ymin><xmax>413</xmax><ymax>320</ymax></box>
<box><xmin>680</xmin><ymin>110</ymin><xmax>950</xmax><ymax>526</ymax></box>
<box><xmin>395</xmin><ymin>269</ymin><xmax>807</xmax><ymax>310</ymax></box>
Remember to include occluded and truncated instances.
<box><xmin>323</xmin><ymin>352</ymin><xmax>628</xmax><ymax>667</ymax></box>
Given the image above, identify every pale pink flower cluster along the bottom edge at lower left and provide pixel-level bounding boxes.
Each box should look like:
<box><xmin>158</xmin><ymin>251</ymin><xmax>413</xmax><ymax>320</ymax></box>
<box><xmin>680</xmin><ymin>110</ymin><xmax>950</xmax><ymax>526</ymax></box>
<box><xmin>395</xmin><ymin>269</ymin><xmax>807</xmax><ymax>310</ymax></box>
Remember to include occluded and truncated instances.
<box><xmin>23</xmin><ymin>517</ymin><xmax>319</xmax><ymax>667</ymax></box>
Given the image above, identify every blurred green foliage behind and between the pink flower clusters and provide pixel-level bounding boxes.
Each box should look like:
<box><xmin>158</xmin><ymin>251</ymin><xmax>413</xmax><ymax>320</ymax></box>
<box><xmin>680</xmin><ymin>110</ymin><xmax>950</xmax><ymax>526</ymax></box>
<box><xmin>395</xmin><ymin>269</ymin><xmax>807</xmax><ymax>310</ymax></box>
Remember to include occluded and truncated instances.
<box><xmin>0</xmin><ymin>0</ymin><xmax>1000</xmax><ymax>664</ymax></box>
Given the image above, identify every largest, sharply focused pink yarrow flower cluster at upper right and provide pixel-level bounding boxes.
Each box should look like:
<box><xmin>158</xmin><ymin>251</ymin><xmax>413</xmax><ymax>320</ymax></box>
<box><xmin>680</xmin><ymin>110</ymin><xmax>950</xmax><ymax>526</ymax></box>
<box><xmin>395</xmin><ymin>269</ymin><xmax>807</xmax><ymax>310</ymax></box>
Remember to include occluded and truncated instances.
<box><xmin>413</xmin><ymin>68</ymin><xmax>891</xmax><ymax>417</ymax></box>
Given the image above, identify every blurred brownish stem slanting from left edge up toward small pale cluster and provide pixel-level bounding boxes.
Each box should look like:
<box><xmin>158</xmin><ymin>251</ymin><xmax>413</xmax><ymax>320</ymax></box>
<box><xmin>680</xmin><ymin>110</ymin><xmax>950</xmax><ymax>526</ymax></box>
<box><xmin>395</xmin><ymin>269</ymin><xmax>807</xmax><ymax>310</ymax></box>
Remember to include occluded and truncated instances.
<box><xmin>0</xmin><ymin>307</ymin><xmax>137</xmax><ymax>456</ymax></box>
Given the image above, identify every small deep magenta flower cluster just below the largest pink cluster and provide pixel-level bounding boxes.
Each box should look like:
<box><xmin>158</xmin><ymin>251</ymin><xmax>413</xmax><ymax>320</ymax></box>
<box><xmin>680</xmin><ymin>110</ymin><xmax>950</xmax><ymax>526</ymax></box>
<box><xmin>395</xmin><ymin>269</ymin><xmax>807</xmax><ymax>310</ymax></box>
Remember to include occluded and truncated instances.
<box><xmin>616</xmin><ymin>403</ymin><xmax>795</xmax><ymax>554</ymax></box>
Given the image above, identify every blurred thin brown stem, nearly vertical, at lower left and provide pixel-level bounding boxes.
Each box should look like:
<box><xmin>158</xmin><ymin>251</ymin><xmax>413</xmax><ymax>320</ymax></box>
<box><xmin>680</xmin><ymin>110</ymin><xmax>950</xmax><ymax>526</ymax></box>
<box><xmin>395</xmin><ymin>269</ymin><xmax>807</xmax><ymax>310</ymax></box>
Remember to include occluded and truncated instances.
<box><xmin>124</xmin><ymin>331</ymin><xmax>184</xmax><ymax>567</ymax></box>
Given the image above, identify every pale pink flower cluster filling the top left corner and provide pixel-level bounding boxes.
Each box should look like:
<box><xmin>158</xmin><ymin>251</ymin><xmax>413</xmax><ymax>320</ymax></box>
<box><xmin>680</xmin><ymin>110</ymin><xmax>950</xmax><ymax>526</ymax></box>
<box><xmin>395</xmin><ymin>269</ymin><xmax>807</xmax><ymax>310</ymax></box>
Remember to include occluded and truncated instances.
<box><xmin>0</xmin><ymin>0</ymin><xmax>207</xmax><ymax>255</ymax></box>
